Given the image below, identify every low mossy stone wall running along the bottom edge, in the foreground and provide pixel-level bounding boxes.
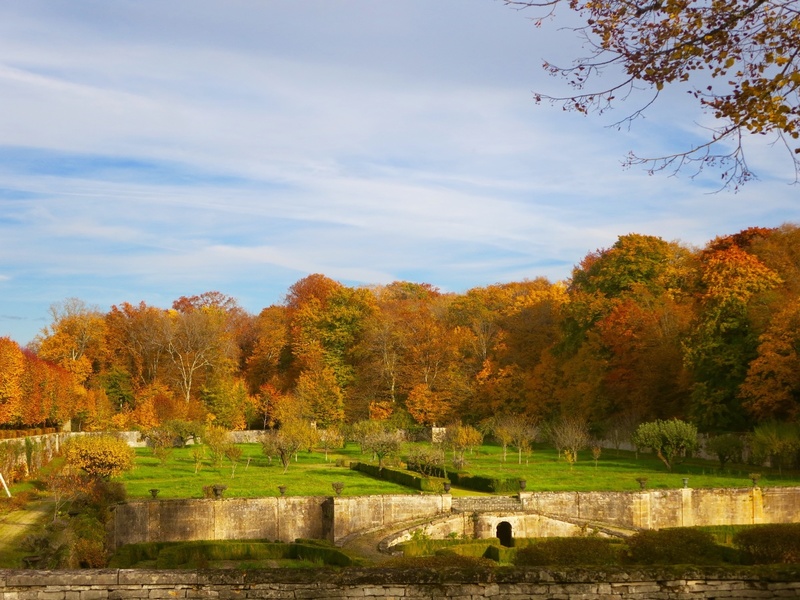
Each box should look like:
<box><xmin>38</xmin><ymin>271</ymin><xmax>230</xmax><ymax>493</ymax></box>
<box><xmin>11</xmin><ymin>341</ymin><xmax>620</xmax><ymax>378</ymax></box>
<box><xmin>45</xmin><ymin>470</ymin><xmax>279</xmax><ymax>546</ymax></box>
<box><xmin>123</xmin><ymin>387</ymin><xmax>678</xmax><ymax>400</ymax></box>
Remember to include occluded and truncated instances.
<box><xmin>0</xmin><ymin>568</ymin><xmax>800</xmax><ymax>600</ymax></box>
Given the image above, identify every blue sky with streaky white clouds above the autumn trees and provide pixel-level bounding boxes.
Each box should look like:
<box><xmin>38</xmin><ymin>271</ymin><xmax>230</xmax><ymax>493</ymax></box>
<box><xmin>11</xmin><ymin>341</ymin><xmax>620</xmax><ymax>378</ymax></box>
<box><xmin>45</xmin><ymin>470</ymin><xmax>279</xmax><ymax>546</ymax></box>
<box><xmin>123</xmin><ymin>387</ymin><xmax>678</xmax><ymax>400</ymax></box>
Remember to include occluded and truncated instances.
<box><xmin>0</xmin><ymin>0</ymin><xmax>800</xmax><ymax>345</ymax></box>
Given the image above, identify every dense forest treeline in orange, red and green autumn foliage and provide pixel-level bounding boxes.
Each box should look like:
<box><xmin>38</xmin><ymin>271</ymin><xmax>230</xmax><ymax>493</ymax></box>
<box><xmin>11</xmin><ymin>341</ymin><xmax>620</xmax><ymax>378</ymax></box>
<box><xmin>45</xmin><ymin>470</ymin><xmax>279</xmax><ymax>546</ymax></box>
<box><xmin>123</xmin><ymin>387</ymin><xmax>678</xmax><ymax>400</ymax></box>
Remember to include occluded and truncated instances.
<box><xmin>0</xmin><ymin>224</ymin><xmax>800</xmax><ymax>432</ymax></box>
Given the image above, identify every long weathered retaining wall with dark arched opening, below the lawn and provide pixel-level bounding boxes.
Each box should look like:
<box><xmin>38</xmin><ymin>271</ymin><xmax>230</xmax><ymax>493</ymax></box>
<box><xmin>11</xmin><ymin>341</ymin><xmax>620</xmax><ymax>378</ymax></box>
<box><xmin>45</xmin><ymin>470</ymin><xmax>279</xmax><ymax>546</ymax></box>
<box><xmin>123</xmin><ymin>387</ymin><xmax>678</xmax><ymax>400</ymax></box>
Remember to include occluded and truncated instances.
<box><xmin>109</xmin><ymin>488</ymin><xmax>800</xmax><ymax>548</ymax></box>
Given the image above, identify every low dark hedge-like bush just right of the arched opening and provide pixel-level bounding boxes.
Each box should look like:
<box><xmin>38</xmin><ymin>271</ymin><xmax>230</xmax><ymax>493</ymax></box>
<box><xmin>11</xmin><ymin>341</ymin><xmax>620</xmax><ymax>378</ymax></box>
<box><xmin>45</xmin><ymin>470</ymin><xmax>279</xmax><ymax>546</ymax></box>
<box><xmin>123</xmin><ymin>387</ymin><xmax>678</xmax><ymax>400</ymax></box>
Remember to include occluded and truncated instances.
<box><xmin>514</xmin><ymin>537</ymin><xmax>621</xmax><ymax>567</ymax></box>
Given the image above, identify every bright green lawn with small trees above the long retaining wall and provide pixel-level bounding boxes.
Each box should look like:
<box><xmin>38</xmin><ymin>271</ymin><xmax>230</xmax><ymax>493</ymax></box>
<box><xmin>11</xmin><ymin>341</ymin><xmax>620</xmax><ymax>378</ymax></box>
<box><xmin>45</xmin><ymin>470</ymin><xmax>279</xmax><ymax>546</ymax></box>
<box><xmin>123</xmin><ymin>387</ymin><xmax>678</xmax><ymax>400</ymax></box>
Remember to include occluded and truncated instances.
<box><xmin>117</xmin><ymin>443</ymin><xmax>800</xmax><ymax>499</ymax></box>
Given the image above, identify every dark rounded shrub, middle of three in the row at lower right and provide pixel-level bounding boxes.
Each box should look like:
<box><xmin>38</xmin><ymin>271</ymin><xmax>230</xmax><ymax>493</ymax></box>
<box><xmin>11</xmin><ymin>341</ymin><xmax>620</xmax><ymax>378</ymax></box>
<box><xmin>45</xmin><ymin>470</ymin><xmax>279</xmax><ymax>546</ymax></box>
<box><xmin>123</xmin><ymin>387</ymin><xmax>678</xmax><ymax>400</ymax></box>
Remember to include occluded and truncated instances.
<box><xmin>627</xmin><ymin>527</ymin><xmax>722</xmax><ymax>565</ymax></box>
